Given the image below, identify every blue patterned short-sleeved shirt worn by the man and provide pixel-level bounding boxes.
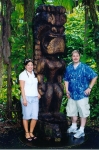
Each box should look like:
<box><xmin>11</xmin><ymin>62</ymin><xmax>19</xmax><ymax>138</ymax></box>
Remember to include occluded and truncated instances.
<box><xmin>64</xmin><ymin>62</ymin><xmax>97</xmax><ymax>100</ymax></box>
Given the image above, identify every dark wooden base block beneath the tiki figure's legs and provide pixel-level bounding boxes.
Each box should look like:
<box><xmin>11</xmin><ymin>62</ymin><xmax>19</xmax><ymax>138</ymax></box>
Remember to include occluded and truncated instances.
<box><xmin>36</xmin><ymin>113</ymin><xmax>68</xmax><ymax>142</ymax></box>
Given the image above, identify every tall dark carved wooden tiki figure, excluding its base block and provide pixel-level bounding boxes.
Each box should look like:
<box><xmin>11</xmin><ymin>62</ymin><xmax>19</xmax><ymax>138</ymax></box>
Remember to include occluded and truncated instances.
<box><xmin>33</xmin><ymin>5</ymin><xmax>66</xmax><ymax>113</ymax></box>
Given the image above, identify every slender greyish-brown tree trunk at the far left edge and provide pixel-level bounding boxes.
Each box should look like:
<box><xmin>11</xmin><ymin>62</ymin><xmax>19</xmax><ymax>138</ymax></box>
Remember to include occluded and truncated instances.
<box><xmin>2</xmin><ymin>0</ymin><xmax>12</xmax><ymax>119</ymax></box>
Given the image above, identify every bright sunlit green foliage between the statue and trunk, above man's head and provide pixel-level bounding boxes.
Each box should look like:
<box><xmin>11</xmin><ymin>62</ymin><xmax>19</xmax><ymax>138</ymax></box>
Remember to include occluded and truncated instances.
<box><xmin>65</xmin><ymin>7</ymin><xmax>85</xmax><ymax>63</ymax></box>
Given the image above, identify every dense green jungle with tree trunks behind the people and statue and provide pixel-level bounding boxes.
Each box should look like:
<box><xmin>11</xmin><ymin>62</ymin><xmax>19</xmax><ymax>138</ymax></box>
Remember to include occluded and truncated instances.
<box><xmin>0</xmin><ymin>0</ymin><xmax>99</xmax><ymax>125</ymax></box>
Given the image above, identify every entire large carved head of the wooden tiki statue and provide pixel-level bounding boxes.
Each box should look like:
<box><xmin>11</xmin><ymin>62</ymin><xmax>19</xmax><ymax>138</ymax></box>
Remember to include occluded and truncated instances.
<box><xmin>34</xmin><ymin>5</ymin><xmax>66</xmax><ymax>59</ymax></box>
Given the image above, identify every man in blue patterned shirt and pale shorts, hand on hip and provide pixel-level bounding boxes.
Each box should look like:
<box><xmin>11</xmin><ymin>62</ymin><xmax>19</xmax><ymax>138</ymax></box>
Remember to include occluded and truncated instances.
<box><xmin>64</xmin><ymin>50</ymin><xmax>97</xmax><ymax>138</ymax></box>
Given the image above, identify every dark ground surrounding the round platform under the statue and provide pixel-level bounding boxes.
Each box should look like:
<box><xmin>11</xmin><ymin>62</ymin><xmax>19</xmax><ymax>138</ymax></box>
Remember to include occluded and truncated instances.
<box><xmin>0</xmin><ymin>118</ymin><xmax>99</xmax><ymax>149</ymax></box>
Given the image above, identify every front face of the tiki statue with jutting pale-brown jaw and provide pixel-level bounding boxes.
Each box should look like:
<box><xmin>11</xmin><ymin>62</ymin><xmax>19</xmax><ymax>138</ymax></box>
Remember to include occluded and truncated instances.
<box><xmin>41</xmin><ymin>9</ymin><xmax>66</xmax><ymax>55</ymax></box>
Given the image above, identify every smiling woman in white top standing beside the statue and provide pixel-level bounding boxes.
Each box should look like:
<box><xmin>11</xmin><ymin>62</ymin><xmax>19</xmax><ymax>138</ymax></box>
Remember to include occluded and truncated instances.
<box><xmin>19</xmin><ymin>59</ymin><xmax>40</xmax><ymax>141</ymax></box>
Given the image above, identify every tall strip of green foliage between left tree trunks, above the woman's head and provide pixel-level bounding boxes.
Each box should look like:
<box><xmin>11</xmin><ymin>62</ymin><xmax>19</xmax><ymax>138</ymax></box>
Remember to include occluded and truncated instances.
<box><xmin>9</xmin><ymin>2</ymin><xmax>26</xmax><ymax>75</ymax></box>
